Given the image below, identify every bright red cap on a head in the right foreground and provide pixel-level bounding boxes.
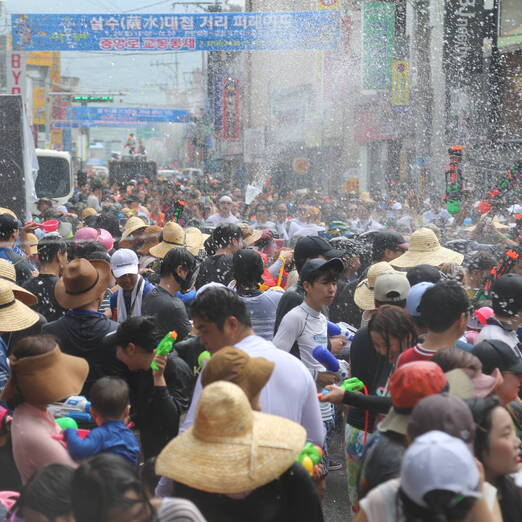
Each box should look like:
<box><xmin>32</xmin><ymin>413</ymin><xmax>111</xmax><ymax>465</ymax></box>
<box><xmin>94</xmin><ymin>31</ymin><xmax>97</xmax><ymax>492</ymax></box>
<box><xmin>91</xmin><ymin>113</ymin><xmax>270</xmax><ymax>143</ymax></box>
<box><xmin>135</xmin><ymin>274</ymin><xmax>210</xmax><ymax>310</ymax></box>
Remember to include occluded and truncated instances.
<box><xmin>390</xmin><ymin>361</ymin><xmax>448</xmax><ymax>410</ymax></box>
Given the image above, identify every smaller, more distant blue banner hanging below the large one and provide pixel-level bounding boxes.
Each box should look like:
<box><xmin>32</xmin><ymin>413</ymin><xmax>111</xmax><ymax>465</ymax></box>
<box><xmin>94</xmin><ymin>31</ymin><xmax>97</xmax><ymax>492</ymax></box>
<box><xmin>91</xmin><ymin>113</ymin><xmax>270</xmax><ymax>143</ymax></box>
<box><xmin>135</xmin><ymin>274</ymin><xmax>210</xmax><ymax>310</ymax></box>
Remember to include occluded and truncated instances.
<box><xmin>54</xmin><ymin>107</ymin><xmax>190</xmax><ymax>129</ymax></box>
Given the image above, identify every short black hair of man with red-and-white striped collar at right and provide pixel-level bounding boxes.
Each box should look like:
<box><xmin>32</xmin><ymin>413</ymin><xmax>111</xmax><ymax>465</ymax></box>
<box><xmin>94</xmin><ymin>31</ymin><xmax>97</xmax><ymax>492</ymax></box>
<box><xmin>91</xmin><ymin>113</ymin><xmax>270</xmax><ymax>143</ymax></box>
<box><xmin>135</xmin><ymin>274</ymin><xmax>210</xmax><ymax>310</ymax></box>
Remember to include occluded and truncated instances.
<box><xmin>419</xmin><ymin>281</ymin><xmax>469</xmax><ymax>333</ymax></box>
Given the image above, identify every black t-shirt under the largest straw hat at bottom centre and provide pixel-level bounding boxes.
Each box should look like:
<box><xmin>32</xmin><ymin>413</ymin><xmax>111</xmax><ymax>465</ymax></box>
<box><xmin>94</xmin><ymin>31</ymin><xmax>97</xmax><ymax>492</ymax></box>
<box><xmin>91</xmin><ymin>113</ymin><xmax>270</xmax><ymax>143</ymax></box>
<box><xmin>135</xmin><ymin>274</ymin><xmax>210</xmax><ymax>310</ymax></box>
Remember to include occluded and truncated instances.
<box><xmin>174</xmin><ymin>464</ymin><xmax>324</xmax><ymax>522</ymax></box>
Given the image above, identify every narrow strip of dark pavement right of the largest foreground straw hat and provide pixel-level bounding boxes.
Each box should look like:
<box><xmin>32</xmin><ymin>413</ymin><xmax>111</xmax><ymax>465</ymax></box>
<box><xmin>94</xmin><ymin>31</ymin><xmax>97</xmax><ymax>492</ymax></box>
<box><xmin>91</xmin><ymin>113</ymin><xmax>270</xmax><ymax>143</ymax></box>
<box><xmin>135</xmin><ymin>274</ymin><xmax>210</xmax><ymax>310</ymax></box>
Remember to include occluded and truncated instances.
<box><xmin>323</xmin><ymin>418</ymin><xmax>351</xmax><ymax>522</ymax></box>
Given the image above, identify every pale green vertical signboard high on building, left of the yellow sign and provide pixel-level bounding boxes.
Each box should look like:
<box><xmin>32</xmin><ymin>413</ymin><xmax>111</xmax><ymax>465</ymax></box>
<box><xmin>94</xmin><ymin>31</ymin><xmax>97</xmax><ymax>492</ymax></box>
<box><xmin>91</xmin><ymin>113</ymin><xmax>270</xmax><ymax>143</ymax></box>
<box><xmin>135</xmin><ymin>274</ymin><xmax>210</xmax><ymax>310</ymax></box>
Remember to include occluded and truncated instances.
<box><xmin>362</xmin><ymin>2</ymin><xmax>395</xmax><ymax>90</ymax></box>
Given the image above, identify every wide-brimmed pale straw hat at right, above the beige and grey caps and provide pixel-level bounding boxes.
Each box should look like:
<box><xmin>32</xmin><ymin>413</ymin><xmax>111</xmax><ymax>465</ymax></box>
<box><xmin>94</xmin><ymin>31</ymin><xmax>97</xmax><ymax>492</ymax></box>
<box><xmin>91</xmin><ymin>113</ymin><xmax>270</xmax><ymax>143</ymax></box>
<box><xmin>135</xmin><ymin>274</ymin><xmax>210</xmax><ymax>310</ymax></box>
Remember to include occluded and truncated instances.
<box><xmin>391</xmin><ymin>228</ymin><xmax>464</xmax><ymax>268</ymax></box>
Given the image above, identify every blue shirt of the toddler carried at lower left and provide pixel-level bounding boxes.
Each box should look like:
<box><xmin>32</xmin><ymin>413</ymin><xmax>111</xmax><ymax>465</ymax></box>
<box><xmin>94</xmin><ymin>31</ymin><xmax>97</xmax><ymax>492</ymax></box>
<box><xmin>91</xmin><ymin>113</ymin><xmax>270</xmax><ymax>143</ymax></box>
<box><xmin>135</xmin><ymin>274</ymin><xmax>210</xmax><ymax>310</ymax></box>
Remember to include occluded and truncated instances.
<box><xmin>64</xmin><ymin>421</ymin><xmax>140</xmax><ymax>466</ymax></box>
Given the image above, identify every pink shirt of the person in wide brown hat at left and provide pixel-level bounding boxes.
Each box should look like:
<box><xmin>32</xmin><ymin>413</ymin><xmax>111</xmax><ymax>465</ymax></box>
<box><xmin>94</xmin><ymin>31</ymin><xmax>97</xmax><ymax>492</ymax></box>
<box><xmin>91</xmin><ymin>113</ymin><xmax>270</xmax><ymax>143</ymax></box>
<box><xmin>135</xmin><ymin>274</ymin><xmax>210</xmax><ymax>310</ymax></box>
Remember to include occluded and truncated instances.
<box><xmin>11</xmin><ymin>403</ymin><xmax>78</xmax><ymax>484</ymax></box>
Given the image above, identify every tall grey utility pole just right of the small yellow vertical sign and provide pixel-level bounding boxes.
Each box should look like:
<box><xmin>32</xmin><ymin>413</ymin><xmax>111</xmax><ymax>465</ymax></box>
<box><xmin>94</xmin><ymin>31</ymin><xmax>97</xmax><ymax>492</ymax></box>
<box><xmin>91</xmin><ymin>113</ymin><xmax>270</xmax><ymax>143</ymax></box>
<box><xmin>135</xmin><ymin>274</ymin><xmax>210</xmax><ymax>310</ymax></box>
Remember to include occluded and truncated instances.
<box><xmin>413</xmin><ymin>0</ymin><xmax>433</xmax><ymax>191</ymax></box>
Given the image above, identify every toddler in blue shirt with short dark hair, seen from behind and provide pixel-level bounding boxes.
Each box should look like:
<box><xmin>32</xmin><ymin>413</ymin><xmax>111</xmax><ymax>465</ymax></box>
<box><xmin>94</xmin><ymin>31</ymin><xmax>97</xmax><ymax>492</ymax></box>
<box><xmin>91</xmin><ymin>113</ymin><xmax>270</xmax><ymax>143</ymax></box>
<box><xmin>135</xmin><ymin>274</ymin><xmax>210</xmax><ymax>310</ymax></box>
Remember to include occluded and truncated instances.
<box><xmin>64</xmin><ymin>377</ymin><xmax>140</xmax><ymax>466</ymax></box>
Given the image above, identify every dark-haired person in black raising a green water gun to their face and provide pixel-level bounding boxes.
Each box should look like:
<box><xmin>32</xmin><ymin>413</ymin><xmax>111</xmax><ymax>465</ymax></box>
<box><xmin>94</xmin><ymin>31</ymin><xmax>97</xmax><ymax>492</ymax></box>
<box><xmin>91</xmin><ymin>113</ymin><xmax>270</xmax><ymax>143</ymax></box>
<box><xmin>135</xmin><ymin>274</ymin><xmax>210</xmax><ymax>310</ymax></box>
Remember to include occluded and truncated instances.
<box><xmin>106</xmin><ymin>316</ymin><xmax>194</xmax><ymax>459</ymax></box>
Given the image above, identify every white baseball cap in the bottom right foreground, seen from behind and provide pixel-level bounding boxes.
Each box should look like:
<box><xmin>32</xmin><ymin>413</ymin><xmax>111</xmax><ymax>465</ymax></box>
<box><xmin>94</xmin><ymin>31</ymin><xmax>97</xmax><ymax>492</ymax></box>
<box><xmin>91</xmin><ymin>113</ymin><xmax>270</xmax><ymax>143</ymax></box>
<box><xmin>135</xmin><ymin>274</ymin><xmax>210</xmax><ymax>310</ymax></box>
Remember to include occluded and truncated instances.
<box><xmin>401</xmin><ymin>431</ymin><xmax>482</xmax><ymax>508</ymax></box>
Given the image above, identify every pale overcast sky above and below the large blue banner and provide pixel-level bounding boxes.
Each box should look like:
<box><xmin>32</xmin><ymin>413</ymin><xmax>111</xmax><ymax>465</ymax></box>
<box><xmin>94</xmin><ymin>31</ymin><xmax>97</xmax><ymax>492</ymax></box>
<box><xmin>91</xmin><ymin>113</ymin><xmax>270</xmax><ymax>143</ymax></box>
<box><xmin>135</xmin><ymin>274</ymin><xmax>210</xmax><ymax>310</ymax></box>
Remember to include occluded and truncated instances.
<box><xmin>0</xmin><ymin>0</ymin><xmax>239</xmax><ymax>104</ymax></box>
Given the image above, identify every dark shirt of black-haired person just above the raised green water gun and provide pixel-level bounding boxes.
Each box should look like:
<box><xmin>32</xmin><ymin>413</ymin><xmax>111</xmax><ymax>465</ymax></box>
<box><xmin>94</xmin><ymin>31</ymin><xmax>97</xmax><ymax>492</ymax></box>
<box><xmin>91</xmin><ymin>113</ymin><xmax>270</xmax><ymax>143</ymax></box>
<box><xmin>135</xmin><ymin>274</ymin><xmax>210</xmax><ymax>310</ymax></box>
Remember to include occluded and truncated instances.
<box><xmin>141</xmin><ymin>286</ymin><xmax>191</xmax><ymax>341</ymax></box>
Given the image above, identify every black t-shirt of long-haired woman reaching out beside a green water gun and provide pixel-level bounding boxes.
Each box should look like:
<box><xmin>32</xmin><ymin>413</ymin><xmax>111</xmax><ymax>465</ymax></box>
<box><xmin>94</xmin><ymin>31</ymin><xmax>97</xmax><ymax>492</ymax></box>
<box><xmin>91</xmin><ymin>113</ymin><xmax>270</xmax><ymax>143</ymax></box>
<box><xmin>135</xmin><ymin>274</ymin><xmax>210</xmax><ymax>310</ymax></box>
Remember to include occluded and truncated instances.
<box><xmin>346</xmin><ymin>326</ymin><xmax>392</xmax><ymax>432</ymax></box>
